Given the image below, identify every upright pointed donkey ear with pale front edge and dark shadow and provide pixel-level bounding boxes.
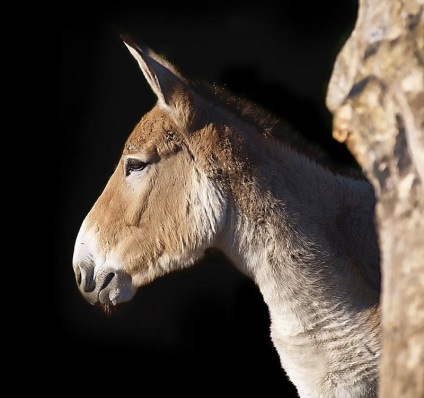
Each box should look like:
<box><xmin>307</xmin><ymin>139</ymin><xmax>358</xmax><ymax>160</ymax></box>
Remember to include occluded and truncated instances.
<box><xmin>121</xmin><ymin>35</ymin><xmax>194</xmax><ymax>124</ymax></box>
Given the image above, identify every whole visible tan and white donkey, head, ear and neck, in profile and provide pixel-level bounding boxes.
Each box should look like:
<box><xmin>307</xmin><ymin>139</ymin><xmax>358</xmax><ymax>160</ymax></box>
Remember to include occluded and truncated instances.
<box><xmin>73</xmin><ymin>38</ymin><xmax>380</xmax><ymax>398</ymax></box>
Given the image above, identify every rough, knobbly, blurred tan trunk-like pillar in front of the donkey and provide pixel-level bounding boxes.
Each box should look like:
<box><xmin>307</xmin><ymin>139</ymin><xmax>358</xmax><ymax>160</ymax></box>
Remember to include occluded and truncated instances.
<box><xmin>327</xmin><ymin>0</ymin><xmax>424</xmax><ymax>398</ymax></box>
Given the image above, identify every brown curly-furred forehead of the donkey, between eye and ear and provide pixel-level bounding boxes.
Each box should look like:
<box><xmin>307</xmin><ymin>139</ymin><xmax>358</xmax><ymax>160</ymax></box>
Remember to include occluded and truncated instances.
<box><xmin>124</xmin><ymin>107</ymin><xmax>176</xmax><ymax>154</ymax></box>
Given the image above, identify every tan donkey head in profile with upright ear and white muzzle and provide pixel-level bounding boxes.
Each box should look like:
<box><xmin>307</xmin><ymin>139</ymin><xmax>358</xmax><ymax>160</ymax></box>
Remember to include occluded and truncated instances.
<box><xmin>73</xmin><ymin>37</ymin><xmax>234</xmax><ymax>309</ymax></box>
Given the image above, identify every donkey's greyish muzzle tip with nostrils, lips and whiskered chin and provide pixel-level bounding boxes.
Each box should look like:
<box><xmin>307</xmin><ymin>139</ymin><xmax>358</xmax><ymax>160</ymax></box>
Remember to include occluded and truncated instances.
<box><xmin>75</xmin><ymin>265</ymin><xmax>136</xmax><ymax>312</ymax></box>
